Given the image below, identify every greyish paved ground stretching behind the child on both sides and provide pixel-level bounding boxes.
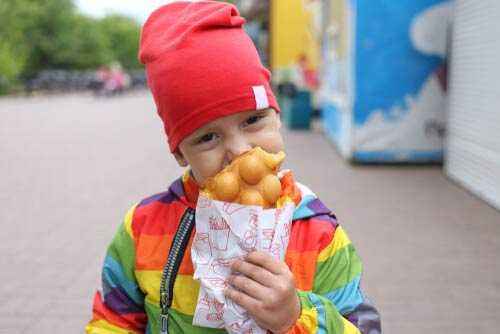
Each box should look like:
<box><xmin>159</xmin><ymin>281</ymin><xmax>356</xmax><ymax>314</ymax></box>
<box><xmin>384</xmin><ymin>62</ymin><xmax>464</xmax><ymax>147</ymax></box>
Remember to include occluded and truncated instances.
<box><xmin>0</xmin><ymin>93</ymin><xmax>500</xmax><ymax>334</ymax></box>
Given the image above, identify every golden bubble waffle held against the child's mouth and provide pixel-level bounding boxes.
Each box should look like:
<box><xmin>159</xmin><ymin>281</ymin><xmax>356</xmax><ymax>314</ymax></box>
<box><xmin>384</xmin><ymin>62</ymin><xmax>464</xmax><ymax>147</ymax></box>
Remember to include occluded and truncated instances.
<box><xmin>202</xmin><ymin>147</ymin><xmax>285</xmax><ymax>208</ymax></box>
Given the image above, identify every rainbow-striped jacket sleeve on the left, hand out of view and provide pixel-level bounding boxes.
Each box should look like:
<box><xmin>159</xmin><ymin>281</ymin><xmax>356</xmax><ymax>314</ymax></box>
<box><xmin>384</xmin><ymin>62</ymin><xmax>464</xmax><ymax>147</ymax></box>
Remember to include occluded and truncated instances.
<box><xmin>85</xmin><ymin>206</ymin><xmax>147</xmax><ymax>334</ymax></box>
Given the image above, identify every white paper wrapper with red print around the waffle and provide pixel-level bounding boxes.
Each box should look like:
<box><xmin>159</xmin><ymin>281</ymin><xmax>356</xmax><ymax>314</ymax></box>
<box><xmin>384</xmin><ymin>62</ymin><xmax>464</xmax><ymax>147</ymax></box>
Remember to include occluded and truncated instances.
<box><xmin>191</xmin><ymin>194</ymin><xmax>295</xmax><ymax>334</ymax></box>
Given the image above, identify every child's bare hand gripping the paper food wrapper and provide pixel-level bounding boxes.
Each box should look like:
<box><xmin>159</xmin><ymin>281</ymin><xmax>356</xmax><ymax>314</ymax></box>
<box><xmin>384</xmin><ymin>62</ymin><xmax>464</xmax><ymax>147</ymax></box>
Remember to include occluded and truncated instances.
<box><xmin>225</xmin><ymin>252</ymin><xmax>300</xmax><ymax>333</ymax></box>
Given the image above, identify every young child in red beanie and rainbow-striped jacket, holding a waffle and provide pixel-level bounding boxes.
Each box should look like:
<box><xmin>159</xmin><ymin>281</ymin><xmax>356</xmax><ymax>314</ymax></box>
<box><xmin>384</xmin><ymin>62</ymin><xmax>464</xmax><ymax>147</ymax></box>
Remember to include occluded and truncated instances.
<box><xmin>86</xmin><ymin>1</ymin><xmax>381</xmax><ymax>334</ymax></box>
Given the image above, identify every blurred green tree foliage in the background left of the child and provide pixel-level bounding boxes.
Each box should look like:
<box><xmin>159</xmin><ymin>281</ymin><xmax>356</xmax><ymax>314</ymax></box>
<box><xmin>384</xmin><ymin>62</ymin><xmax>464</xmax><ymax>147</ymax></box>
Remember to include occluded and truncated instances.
<box><xmin>0</xmin><ymin>0</ymin><xmax>145</xmax><ymax>93</ymax></box>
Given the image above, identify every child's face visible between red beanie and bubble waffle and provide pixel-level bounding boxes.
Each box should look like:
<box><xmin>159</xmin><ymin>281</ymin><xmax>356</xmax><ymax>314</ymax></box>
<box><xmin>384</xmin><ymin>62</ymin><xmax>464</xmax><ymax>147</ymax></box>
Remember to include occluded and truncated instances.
<box><xmin>174</xmin><ymin>109</ymin><xmax>284</xmax><ymax>185</ymax></box>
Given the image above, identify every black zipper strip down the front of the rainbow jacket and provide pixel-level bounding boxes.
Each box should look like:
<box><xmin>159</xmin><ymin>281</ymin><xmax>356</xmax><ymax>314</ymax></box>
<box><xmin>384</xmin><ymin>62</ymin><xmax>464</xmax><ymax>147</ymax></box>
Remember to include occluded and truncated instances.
<box><xmin>160</xmin><ymin>208</ymin><xmax>195</xmax><ymax>334</ymax></box>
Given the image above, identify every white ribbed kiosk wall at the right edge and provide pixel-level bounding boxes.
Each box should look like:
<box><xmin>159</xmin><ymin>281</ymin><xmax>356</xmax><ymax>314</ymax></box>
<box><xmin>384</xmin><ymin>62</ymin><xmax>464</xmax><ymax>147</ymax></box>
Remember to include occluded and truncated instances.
<box><xmin>445</xmin><ymin>0</ymin><xmax>500</xmax><ymax>209</ymax></box>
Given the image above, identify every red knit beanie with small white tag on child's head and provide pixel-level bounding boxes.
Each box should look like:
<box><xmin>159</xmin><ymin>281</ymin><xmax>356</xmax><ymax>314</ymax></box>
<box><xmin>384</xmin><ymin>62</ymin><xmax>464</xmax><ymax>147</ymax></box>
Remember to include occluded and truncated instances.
<box><xmin>139</xmin><ymin>1</ymin><xmax>279</xmax><ymax>152</ymax></box>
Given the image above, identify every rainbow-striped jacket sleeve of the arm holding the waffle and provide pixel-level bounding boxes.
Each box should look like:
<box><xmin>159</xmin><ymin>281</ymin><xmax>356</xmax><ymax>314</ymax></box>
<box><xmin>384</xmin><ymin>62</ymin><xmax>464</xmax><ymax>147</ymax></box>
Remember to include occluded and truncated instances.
<box><xmin>290</xmin><ymin>225</ymin><xmax>381</xmax><ymax>334</ymax></box>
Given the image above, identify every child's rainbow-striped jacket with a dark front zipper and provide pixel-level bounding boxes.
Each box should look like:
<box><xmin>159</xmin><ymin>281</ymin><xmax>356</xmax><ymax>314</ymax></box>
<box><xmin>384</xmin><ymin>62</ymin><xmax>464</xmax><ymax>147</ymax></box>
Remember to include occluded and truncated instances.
<box><xmin>86</xmin><ymin>174</ymin><xmax>381</xmax><ymax>334</ymax></box>
